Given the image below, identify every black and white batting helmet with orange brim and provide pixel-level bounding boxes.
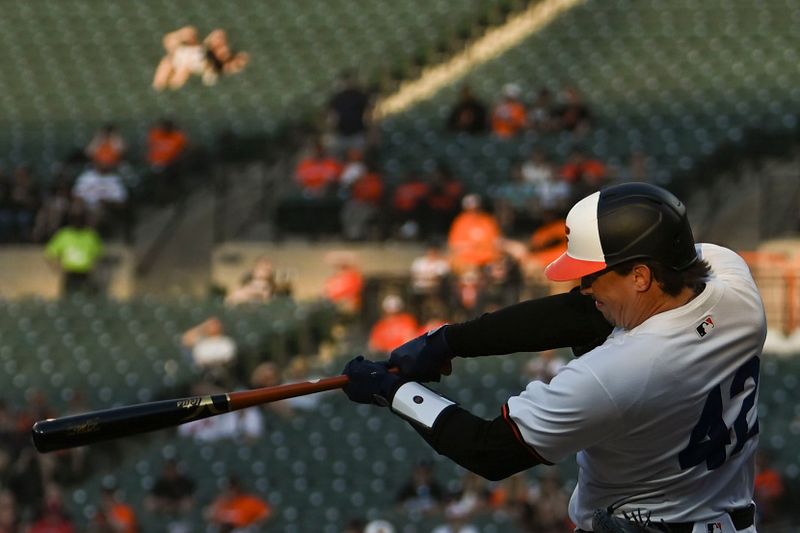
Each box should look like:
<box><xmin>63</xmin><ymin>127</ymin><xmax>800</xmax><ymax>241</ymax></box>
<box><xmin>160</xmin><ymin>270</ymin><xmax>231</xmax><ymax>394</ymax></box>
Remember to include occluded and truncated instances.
<box><xmin>544</xmin><ymin>183</ymin><xmax>697</xmax><ymax>281</ymax></box>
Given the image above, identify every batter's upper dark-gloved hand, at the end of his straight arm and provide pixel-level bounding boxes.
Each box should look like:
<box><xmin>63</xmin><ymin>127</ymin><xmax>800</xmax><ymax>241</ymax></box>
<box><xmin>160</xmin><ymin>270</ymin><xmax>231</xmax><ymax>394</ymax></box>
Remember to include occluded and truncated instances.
<box><xmin>389</xmin><ymin>326</ymin><xmax>453</xmax><ymax>383</ymax></box>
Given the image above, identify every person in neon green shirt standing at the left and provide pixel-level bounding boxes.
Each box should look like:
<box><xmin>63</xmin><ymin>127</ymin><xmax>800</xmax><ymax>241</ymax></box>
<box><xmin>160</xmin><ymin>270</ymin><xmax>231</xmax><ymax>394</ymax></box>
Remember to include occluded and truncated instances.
<box><xmin>45</xmin><ymin>208</ymin><xmax>104</xmax><ymax>295</ymax></box>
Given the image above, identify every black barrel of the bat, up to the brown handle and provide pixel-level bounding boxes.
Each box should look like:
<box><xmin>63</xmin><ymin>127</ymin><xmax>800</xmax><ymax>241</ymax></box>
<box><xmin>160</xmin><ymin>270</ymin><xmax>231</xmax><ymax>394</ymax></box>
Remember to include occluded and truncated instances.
<box><xmin>31</xmin><ymin>394</ymin><xmax>230</xmax><ymax>452</ymax></box>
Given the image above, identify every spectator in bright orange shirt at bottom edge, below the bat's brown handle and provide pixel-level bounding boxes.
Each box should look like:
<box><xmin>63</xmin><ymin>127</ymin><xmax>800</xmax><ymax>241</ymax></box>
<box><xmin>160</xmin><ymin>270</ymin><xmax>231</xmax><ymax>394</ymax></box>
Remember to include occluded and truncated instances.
<box><xmin>207</xmin><ymin>476</ymin><xmax>273</xmax><ymax>532</ymax></box>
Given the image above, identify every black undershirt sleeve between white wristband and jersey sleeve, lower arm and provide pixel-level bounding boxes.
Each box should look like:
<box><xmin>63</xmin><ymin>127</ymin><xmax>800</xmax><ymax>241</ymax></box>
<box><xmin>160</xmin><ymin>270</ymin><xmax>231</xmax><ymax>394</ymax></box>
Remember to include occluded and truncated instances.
<box><xmin>409</xmin><ymin>405</ymin><xmax>550</xmax><ymax>481</ymax></box>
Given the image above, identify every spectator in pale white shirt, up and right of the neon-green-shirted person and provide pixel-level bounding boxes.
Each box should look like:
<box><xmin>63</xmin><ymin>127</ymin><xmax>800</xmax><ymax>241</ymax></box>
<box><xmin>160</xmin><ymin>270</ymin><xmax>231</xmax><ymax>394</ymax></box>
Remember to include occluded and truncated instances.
<box><xmin>72</xmin><ymin>165</ymin><xmax>129</xmax><ymax>235</ymax></box>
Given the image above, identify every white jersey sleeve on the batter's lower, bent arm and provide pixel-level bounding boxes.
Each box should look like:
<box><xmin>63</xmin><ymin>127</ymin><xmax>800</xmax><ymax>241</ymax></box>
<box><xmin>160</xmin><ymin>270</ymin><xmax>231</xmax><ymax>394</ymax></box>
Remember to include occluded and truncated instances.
<box><xmin>504</xmin><ymin>359</ymin><xmax>623</xmax><ymax>463</ymax></box>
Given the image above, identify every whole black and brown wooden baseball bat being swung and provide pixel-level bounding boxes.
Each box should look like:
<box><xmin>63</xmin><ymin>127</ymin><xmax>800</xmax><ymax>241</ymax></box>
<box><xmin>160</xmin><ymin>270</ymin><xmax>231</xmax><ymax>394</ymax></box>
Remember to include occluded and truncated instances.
<box><xmin>31</xmin><ymin>369</ymin><xmax>356</xmax><ymax>453</ymax></box>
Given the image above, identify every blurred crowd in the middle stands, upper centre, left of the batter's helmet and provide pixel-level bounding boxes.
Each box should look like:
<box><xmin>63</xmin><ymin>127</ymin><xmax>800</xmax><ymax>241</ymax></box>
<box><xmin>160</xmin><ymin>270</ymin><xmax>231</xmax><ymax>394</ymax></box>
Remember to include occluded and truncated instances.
<box><xmin>278</xmin><ymin>73</ymin><xmax>653</xmax><ymax>247</ymax></box>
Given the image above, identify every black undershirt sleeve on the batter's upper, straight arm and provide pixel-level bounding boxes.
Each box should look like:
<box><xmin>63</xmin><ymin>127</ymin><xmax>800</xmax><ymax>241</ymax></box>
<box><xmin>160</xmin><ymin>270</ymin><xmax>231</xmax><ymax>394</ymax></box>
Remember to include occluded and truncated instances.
<box><xmin>445</xmin><ymin>289</ymin><xmax>612</xmax><ymax>357</ymax></box>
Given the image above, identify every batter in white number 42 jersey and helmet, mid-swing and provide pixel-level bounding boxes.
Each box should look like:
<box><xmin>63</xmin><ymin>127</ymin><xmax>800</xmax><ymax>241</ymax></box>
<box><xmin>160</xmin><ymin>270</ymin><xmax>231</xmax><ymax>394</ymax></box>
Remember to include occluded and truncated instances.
<box><xmin>344</xmin><ymin>183</ymin><xmax>766</xmax><ymax>533</ymax></box>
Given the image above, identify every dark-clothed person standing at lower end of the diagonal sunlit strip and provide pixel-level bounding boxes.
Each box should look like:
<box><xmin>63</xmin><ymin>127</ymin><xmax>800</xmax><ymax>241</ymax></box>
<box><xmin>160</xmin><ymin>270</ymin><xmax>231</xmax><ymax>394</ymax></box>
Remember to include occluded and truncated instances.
<box><xmin>328</xmin><ymin>71</ymin><xmax>372</xmax><ymax>156</ymax></box>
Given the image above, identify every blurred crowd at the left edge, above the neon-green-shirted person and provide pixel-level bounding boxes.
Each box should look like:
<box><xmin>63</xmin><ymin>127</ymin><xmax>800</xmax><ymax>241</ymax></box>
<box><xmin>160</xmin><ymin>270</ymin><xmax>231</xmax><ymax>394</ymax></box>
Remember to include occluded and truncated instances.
<box><xmin>0</xmin><ymin>118</ymin><xmax>192</xmax><ymax>244</ymax></box>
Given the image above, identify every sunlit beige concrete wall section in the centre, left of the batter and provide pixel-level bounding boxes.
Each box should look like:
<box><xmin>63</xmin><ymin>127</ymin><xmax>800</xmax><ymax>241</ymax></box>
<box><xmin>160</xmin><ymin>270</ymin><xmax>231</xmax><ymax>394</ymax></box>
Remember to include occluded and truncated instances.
<box><xmin>211</xmin><ymin>242</ymin><xmax>425</xmax><ymax>299</ymax></box>
